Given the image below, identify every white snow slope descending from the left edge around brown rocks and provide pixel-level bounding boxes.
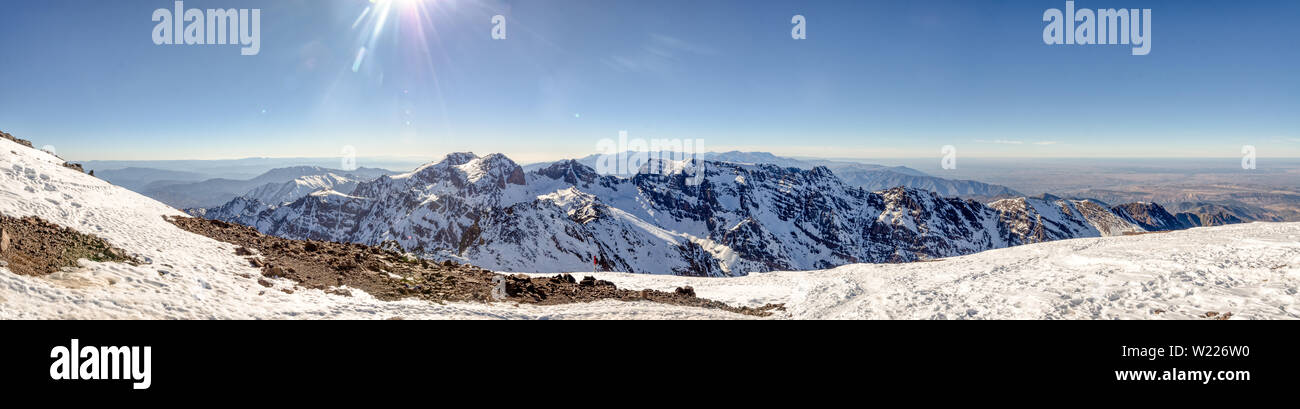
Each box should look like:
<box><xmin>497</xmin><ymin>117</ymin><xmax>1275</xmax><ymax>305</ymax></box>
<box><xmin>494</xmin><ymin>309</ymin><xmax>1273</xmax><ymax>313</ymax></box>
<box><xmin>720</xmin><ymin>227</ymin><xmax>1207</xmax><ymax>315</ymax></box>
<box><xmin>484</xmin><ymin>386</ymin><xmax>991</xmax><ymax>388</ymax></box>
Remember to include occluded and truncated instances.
<box><xmin>0</xmin><ymin>139</ymin><xmax>691</xmax><ymax>319</ymax></box>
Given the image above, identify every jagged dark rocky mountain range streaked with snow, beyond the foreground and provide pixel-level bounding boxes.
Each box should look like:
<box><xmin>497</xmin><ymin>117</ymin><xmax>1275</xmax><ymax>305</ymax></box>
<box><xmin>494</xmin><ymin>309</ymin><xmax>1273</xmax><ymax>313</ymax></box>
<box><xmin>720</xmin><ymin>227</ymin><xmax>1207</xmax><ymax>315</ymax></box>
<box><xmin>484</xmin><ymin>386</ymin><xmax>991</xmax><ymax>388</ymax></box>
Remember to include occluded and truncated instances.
<box><xmin>195</xmin><ymin>153</ymin><xmax>1206</xmax><ymax>277</ymax></box>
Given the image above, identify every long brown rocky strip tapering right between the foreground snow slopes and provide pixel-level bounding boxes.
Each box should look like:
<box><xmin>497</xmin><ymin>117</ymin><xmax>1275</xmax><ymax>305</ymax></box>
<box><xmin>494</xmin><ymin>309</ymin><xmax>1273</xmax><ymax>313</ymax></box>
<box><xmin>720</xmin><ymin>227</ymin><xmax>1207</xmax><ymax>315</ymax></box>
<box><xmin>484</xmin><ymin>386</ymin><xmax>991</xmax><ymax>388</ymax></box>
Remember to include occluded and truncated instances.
<box><xmin>168</xmin><ymin>217</ymin><xmax>784</xmax><ymax>317</ymax></box>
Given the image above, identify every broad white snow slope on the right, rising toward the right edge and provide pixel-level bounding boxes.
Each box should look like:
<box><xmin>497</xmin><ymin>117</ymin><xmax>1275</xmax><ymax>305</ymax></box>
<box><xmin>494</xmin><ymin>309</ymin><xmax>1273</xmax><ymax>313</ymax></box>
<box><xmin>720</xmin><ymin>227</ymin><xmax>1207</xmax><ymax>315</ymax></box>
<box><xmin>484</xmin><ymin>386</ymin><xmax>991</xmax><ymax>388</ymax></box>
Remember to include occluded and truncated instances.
<box><xmin>533</xmin><ymin>223</ymin><xmax>1300</xmax><ymax>319</ymax></box>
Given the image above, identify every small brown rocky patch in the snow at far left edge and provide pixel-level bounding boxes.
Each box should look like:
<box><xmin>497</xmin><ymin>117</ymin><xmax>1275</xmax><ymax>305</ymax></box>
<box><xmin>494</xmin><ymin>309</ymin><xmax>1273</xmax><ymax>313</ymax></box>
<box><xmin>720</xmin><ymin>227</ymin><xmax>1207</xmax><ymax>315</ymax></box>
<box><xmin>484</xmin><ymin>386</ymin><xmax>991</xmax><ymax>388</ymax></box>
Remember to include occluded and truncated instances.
<box><xmin>0</xmin><ymin>216</ymin><xmax>135</xmax><ymax>275</ymax></box>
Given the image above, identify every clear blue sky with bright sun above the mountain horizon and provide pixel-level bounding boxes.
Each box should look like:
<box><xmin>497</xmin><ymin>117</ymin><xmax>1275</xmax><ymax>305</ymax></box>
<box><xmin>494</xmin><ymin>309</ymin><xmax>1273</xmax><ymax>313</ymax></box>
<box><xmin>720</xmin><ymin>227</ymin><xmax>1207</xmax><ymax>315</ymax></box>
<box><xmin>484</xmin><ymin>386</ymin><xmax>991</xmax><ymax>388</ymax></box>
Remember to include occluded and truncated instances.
<box><xmin>0</xmin><ymin>0</ymin><xmax>1300</xmax><ymax>162</ymax></box>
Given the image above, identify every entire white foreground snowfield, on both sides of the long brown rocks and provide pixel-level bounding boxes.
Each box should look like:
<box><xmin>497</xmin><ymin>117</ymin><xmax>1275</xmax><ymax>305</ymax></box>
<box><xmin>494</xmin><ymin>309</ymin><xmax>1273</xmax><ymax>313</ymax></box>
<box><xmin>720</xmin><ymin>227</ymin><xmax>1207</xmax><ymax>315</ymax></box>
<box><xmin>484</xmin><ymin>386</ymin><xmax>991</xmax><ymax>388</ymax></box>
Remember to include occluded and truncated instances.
<box><xmin>0</xmin><ymin>140</ymin><xmax>1300</xmax><ymax>319</ymax></box>
